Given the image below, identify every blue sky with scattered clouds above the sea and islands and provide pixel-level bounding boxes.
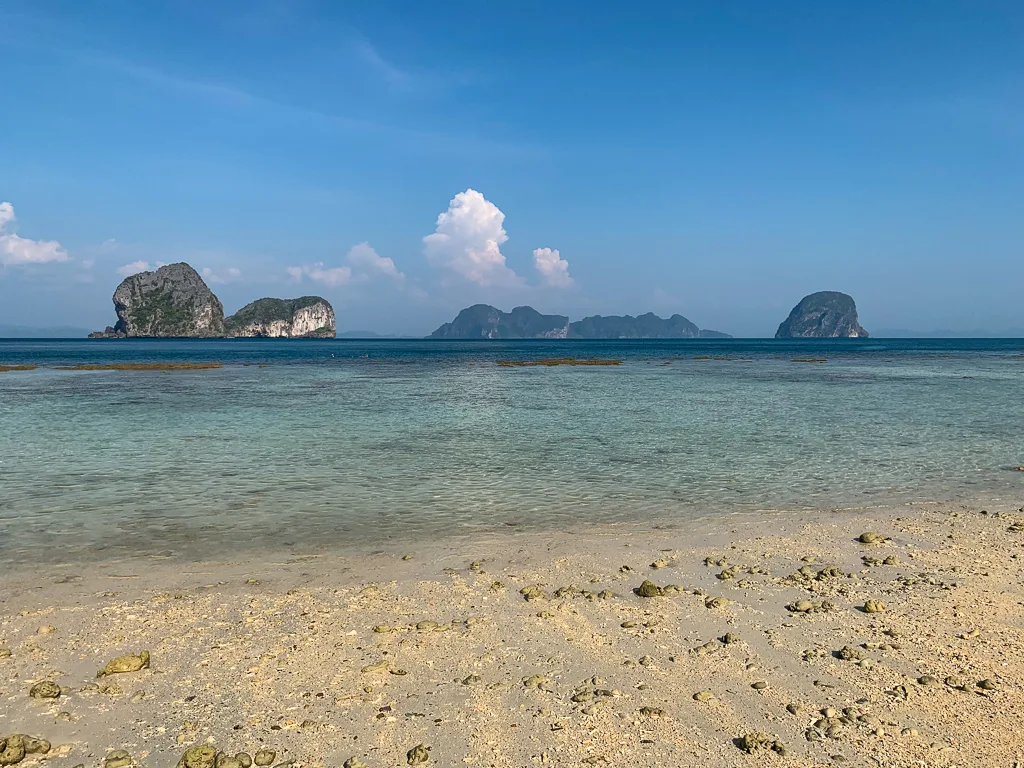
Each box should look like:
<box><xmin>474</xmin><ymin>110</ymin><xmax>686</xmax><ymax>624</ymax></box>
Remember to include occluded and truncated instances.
<box><xmin>0</xmin><ymin>0</ymin><xmax>1024</xmax><ymax>336</ymax></box>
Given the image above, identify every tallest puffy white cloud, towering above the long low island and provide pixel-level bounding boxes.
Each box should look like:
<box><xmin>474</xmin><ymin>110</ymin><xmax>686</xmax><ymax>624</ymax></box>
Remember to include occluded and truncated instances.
<box><xmin>423</xmin><ymin>189</ymin><xmax>521</xmax><ymax>286</ymax></box>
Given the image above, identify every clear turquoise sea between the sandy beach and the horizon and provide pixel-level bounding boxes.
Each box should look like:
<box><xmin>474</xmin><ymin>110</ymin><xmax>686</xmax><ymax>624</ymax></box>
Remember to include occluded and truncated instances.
<box><xmin>0</xmin><ymin>340</ymin><xmax>1024</xmax><ymax>563</ymax></box>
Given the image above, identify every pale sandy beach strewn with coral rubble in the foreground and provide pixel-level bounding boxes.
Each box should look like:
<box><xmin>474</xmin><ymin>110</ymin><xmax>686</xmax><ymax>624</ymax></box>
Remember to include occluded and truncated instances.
<box><xmin>0</xmin><ymin>502</ymin><xmax>1024</xmax><ymax>768</ymax></box>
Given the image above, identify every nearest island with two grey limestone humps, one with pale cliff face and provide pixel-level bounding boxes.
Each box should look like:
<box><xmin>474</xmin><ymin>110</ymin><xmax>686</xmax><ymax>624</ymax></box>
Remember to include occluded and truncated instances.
<box><xmin>89</xmin><ymin>262</ymin><xmax>335</xmax><ymax>339</ymax></box>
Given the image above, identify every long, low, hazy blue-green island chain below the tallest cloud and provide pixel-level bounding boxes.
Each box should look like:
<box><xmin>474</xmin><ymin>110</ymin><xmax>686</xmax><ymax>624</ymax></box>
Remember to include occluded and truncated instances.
<box><xmin>429</xmin><ymin>304</ymin><xmax>732</xmax><ymax>339</ymax></box>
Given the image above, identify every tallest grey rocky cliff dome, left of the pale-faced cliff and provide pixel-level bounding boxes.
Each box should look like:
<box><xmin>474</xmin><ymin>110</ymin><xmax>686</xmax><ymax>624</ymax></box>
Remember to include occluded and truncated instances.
<box><xmin>90</xmin><ymin>263</ymin><xmax>224</xmax><ymax>338</ymax></box>
